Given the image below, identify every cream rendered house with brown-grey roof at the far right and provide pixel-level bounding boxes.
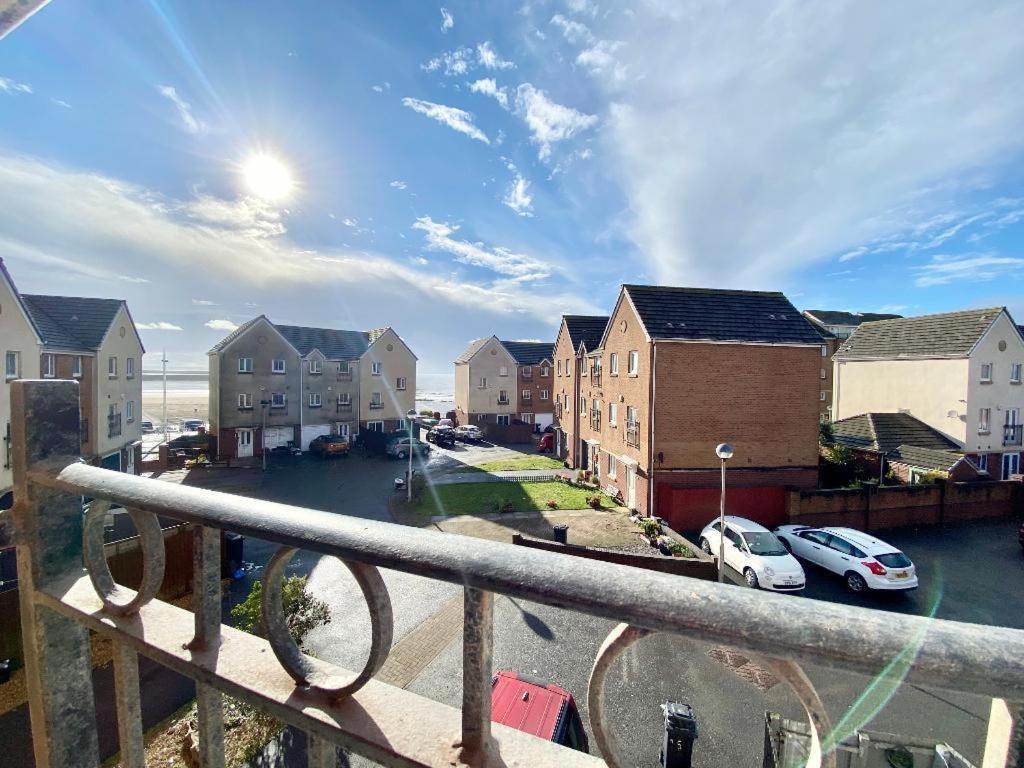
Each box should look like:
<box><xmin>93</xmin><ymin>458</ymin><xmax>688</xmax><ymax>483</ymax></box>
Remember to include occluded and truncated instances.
<box><xmin>833</xmin><ymin>307</ymin><xmax>1024</xmax><ymax>479</ymax></box>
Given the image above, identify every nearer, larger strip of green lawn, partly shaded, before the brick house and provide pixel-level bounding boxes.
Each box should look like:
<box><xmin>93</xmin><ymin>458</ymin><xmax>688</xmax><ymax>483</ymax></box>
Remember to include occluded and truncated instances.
<box><xmin>416</xmin><ymin>480</ymin><xmax>612</xmax><ymax>517</ymax></box>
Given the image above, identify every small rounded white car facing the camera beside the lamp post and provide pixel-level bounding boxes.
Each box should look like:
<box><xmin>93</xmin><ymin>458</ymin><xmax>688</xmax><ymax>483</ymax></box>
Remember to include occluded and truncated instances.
<box><xmin>700</xmin><ymin>515</ymin><xmax>807</xmax><ymax>592</ymax></box>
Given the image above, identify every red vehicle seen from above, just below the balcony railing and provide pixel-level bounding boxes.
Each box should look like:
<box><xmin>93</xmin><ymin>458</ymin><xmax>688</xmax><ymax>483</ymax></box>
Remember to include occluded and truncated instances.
<box><xmin>490</xmin><ymin>671</ymin><xmax>588</xmax><ymax>752</ymax></box>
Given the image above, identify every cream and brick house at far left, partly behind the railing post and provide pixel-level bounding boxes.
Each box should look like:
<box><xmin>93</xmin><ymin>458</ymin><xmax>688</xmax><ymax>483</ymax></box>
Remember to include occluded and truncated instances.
<box><xmin>0</xmin><ymin>260</ymin><xmax>144</xmax><ymax>509</ymax></box>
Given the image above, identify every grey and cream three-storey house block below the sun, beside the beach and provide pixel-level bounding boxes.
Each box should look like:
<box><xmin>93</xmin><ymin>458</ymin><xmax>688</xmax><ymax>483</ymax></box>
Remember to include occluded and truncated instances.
<box><xmin>209</xmin><ymin>315</ymin><xmax>416</xmax><ymax>460</ymax></box>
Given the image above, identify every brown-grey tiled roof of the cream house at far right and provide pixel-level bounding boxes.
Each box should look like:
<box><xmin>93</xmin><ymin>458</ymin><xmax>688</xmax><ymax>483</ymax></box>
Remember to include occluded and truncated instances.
<box><xmin>836</xmin><ymin>307</ymin><xmax>1004</xmax><ymax>359</ymax></box>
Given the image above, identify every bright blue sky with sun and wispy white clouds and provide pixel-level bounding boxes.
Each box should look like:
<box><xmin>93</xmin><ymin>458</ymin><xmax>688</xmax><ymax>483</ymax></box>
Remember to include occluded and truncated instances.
<box><xmin>0</xmin><ymin>0</ymin><xmax>1024</xmax><ymax>373</ymax></box>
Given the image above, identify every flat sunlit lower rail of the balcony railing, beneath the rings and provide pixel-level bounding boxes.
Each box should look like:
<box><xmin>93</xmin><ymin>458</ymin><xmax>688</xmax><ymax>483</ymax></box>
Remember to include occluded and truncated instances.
<box><xmin>37</xmin><ymin>577</ymin><xmax>604</xmax><ymax>768</ymax></box>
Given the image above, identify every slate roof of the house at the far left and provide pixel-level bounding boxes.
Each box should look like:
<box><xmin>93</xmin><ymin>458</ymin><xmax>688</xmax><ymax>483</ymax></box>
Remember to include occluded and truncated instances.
<box><xmin>20</xmin><ymin>294</ymin><xmax>124</xmax><ymax>351</ymax></box>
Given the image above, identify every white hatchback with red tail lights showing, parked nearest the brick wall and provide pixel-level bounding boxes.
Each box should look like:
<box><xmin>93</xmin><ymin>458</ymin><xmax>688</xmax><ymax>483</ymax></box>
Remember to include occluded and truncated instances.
<box><xmin>775</xmin><ymin>525</ymin><xmax>918</xmax><ymax>592</ymax></box>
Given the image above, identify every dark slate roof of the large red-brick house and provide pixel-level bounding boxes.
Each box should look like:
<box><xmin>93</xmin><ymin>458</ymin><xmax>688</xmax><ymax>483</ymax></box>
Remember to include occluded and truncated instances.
<box><xmin>623</xmin><ymin>285</ymin><xmax>823</xmax><ymax>344</ymax></box>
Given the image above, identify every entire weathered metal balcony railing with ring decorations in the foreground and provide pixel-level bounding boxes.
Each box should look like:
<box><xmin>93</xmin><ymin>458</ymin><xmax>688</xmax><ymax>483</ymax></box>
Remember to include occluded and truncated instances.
<box><xmin>0</xmin><ymin>381</ymin><xmax>1024</xmax><ymax>768</ymax></box>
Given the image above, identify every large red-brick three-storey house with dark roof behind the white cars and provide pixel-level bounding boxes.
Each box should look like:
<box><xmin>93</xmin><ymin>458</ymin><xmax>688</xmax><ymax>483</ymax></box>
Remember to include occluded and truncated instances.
<box><xmin>555</xmin><ymin>285</ymin><xmax>822</xmax><ymax>530</ymax></box>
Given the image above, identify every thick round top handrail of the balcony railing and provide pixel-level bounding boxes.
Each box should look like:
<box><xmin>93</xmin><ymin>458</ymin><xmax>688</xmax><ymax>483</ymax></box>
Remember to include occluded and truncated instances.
<box><xmin>44</xmin><ymin>464</ymin><xmax>1024</xmax><ymax>698</ymax></box>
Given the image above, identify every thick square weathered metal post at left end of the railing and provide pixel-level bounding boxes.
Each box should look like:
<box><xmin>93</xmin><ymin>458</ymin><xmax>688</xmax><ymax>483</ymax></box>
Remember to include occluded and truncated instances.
<box><xmin>11</xmin><ymin>381</ymin><xmax>99</xmax><ymax>768</ymax></box>
